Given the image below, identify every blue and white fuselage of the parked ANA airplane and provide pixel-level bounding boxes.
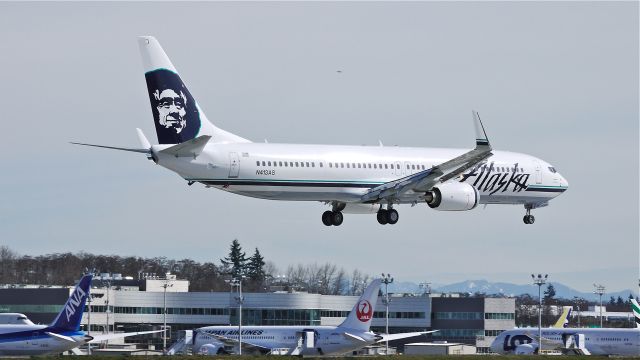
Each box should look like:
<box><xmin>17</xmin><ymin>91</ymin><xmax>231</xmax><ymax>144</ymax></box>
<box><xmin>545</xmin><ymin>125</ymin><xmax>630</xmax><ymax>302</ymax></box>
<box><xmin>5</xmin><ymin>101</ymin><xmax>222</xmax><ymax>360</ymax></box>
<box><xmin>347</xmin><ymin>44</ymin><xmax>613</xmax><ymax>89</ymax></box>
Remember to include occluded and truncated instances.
<box><xmin>0</xmin><ymin>325</ymin><xmax>90</xmax><ymax>356</ymax></box>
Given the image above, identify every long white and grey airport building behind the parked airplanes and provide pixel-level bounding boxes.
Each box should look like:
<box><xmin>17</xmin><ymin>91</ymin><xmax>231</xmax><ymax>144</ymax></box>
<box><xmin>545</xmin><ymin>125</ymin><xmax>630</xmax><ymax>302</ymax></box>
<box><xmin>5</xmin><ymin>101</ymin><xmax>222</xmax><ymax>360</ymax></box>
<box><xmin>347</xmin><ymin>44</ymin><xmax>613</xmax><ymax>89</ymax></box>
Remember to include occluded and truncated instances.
<box><xmin>0</xmin><ymin>278</ymin><xmax>515</xmax><ymax>352</ymax></box>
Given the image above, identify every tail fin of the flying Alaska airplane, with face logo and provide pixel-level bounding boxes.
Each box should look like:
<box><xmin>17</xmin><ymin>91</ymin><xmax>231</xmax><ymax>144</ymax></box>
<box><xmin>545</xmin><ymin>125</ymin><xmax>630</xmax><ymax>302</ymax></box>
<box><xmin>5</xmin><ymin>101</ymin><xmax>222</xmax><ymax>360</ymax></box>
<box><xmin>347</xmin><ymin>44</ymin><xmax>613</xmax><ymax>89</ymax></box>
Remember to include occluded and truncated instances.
<box><xmin>138</xmin><ymin>36</ymin><xmax>249</xmax><ymax>144</ymax></box>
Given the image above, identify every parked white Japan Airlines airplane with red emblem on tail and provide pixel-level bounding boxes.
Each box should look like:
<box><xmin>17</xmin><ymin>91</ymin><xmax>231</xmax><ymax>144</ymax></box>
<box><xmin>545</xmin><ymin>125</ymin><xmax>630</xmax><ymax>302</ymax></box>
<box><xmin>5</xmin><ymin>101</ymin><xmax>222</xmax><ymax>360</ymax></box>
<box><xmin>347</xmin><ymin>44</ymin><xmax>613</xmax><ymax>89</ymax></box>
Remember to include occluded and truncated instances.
<box><xmin>192</xmin><ymin>279</ymin><xmax>434</xmax><ymax>355</ymax></box>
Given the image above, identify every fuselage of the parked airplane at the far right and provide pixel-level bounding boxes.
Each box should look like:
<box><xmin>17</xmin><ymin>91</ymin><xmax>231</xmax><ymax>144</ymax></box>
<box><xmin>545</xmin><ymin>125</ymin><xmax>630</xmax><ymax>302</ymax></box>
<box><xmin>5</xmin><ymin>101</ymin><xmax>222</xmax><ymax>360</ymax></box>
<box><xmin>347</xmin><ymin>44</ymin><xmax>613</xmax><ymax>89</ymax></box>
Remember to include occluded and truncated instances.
<box><xmin>491</xmin><ymin>328</ymin><xmax>640</xmax><ymax>356</ymax></box>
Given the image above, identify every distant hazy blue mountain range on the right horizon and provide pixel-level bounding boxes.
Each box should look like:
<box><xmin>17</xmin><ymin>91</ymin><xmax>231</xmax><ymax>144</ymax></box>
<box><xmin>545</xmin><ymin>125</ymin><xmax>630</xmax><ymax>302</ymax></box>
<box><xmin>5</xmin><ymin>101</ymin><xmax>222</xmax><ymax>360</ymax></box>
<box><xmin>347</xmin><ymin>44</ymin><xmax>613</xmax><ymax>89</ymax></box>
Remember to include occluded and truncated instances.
<box><xmin>389</xmin><ymin>280</ymin><xmax>638</xmax><ymax>302</ymax></box>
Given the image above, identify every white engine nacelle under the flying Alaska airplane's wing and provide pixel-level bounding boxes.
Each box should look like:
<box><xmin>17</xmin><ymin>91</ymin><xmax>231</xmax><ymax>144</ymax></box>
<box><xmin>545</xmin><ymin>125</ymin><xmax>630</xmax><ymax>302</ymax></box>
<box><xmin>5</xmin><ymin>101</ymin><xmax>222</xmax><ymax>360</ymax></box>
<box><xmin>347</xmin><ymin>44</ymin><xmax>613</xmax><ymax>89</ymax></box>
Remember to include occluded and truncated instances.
<box><xmin>426</xmin><ymin>182</ymin><xmax>480</xmax><ymax>211</ymax></box>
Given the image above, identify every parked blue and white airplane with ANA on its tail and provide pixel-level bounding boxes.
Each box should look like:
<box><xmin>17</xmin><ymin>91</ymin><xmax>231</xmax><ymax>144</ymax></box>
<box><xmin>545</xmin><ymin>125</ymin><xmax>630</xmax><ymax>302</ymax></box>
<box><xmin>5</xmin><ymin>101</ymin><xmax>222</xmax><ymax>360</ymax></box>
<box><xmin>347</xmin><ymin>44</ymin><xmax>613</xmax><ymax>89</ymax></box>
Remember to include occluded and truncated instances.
<box><xmin>0</xmin><ymin>275</ymin><xmax>162</xmax><ymax>356</ymax></box>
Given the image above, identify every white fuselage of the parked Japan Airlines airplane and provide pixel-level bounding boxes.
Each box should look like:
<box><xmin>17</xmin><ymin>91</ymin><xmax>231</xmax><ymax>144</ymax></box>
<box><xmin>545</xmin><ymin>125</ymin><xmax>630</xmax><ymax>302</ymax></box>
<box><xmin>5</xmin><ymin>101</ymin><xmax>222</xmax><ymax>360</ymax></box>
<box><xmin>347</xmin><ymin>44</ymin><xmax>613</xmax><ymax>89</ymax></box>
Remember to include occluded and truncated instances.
<box><xmin>193</xmin><ymin>326</ymin><xmax>376</xmax><ymax>355</ymax></box>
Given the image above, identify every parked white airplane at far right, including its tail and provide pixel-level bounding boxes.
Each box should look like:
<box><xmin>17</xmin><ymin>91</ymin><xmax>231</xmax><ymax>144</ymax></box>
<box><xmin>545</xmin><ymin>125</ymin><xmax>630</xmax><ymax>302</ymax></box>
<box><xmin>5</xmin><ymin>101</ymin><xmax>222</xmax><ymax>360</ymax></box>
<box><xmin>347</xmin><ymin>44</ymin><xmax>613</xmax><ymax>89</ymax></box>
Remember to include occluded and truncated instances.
<box><xmin>491</xmin><ymin>299</ymin><xmax>640</xmax><ymax>356</ymax></box>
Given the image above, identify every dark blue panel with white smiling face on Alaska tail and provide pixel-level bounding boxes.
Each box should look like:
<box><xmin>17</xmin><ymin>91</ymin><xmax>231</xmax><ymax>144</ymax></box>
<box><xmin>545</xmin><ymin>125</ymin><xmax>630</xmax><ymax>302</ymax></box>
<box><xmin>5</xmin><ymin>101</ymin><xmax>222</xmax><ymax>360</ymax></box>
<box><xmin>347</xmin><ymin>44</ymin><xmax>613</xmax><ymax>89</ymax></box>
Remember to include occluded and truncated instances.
<box><xmin>145</xmin><ymin>69</ymin><xmax>200</xmax><ymax>144</ymax></box>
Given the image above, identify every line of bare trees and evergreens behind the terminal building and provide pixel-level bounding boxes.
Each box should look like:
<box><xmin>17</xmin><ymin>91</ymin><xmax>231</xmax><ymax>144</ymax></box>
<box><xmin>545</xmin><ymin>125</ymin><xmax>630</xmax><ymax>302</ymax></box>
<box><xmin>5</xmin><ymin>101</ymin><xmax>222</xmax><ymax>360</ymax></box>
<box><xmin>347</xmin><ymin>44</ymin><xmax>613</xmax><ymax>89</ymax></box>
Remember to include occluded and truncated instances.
<box><xmin>0</xmin><ymin>240</ymin><xmax>372</xmax><ymax>295</ymax></box>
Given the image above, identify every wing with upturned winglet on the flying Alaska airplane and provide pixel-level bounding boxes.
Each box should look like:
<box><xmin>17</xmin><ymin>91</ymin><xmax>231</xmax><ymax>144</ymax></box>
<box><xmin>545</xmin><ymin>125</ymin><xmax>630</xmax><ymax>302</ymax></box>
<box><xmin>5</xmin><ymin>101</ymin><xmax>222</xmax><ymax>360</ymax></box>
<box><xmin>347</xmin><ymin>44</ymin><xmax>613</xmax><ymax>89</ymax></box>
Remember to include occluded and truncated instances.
<box><xmin>361</xmin><ymin>111</ymin><xmax>492</xmax><ymax>202</ymax></box>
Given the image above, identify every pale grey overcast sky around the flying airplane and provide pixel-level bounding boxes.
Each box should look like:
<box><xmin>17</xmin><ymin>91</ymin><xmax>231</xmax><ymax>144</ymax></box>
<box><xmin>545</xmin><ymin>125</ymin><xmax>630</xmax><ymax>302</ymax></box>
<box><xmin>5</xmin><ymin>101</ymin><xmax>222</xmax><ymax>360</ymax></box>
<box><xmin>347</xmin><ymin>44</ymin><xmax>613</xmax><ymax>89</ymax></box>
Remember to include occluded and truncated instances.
<box><xmin>0</xmin><ymin>2</ymin><xmax>640</xmax><ymax>291</ymax></box>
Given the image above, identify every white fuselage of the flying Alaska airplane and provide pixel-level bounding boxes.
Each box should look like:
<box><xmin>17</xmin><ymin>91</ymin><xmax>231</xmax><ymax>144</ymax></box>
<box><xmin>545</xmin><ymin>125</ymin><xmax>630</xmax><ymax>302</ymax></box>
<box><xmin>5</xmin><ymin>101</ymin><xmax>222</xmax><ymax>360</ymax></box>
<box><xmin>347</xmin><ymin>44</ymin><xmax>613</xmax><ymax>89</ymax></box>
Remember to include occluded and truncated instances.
<box><xmin>153</xmin><ymin>143</ymin><xmax>568</xmax><ymax>204</ymax></box>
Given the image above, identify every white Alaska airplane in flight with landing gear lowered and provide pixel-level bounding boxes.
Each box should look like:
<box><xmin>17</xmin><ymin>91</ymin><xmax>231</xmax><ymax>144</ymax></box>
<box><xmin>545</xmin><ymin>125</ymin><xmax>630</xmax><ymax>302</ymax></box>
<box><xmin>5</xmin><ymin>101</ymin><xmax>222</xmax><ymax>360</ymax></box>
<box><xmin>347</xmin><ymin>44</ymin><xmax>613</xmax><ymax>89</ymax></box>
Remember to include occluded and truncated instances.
<box><xmin>74</xmin><ymin>36</ymin><xmax>568</xmax><ymax>226</ymax></box>
